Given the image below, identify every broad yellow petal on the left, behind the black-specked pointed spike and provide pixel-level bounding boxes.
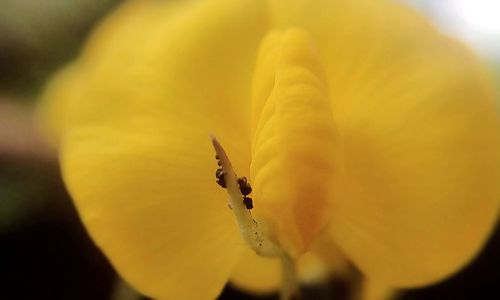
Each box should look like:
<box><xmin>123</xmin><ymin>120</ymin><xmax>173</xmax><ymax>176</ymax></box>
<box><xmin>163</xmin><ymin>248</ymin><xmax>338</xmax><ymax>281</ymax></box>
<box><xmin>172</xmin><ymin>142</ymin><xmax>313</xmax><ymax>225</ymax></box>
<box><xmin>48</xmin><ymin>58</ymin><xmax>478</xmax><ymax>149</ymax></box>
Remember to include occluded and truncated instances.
<box><xmin>47</xmin><ymin>0</ymin><xmax>265</xmax><ymax>299</ymax></box>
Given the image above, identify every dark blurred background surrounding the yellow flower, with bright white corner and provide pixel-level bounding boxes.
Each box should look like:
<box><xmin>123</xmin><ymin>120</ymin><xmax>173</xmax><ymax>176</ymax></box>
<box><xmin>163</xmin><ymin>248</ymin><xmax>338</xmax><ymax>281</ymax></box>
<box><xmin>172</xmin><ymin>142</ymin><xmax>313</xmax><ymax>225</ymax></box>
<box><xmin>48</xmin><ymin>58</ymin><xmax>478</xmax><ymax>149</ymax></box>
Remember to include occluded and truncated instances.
<box><xmin>0</xmin><ymin>0</ymin><xmax>500</xmax><ymax>300</ymax></box>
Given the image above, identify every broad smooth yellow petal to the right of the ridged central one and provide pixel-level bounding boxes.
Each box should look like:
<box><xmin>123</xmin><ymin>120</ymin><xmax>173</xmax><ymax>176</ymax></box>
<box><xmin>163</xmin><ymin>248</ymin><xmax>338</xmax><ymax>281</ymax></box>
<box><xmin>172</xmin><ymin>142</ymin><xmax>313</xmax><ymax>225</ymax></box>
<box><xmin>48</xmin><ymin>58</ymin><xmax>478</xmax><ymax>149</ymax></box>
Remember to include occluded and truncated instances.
<box><xmin>271</xmin><ymin>0</ymin><xmax>500</xmax><ymax>286</ymax></box>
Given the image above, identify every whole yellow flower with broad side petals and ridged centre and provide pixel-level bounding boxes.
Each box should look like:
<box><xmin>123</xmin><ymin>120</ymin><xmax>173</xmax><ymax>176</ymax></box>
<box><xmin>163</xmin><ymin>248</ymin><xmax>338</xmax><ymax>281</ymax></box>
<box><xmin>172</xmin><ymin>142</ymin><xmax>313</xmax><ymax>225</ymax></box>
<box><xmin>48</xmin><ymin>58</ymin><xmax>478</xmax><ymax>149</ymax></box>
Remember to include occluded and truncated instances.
<box><xmin>43</xmin><ymin>0</ymin><xmax>500</xmax><ymax>299</ymax></box>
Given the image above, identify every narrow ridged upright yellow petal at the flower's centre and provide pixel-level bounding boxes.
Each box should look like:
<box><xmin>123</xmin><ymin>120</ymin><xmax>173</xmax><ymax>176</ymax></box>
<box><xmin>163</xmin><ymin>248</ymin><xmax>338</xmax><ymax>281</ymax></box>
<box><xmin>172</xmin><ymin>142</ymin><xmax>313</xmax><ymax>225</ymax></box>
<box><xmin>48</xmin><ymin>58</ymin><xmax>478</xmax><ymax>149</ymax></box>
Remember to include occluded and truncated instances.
<box><xmin>251</xmin><ymin>29</ymin><xmax>340</xmax><ymax>255</ymax></box>
